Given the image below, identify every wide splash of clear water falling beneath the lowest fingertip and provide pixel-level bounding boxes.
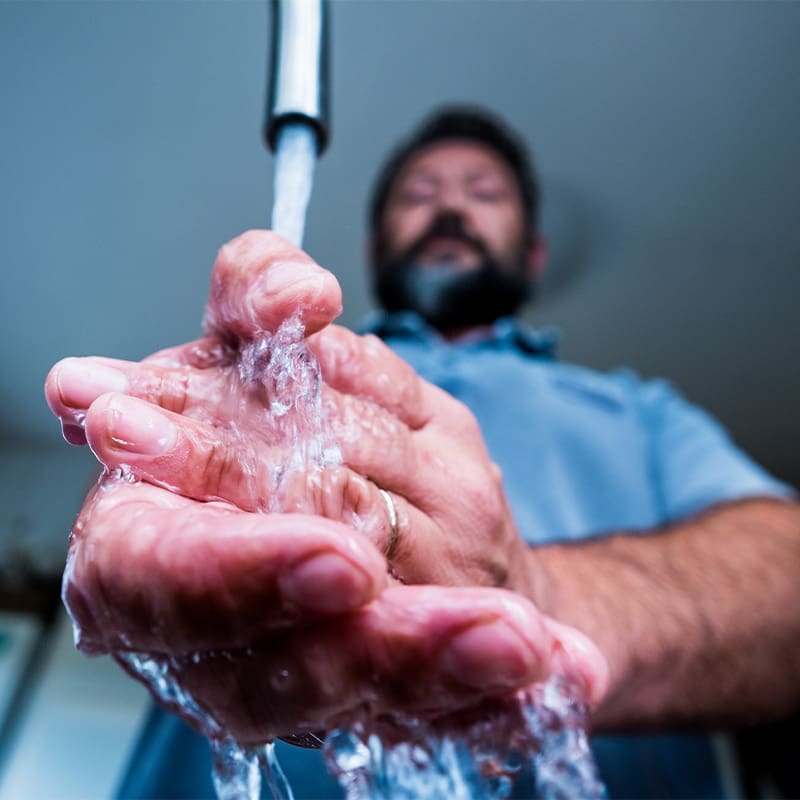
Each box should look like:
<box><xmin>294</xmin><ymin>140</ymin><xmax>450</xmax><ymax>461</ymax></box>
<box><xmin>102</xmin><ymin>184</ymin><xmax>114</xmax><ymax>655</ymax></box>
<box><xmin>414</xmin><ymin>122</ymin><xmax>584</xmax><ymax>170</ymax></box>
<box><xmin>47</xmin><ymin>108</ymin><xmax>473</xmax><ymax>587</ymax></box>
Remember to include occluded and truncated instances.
<box><xmin>325</xmin><ymin>679</ymin><xmax>606</xmax><ymax>800</ymax></box>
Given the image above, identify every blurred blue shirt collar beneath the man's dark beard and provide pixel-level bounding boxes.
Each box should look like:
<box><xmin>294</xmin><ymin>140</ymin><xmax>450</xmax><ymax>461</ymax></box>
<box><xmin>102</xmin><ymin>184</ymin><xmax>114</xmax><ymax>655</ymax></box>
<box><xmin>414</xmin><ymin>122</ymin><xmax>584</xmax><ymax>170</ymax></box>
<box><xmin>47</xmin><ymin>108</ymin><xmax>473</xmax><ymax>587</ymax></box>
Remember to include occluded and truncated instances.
<box><xmin>359</xmin><ymin>311</ymin><xmax>560</xmax><ymax>358</ymax></box>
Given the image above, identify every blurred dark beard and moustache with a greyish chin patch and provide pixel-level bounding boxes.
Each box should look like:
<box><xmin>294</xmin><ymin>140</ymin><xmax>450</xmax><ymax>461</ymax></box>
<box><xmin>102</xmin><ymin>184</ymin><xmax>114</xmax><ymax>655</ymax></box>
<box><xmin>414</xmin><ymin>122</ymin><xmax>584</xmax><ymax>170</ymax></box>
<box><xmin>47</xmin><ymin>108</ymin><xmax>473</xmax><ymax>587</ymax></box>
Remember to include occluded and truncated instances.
<box><xmin>373</xmin><ymin>212</ymin><xmax>533</xmax><ymax>333</ymax></box>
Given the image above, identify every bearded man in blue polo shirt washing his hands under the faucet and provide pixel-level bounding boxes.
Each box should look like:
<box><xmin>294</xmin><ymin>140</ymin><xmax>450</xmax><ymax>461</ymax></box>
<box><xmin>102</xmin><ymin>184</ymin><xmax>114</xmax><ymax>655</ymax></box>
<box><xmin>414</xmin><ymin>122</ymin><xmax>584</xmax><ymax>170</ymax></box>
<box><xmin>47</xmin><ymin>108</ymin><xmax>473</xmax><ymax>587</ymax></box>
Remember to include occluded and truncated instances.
<box><xmin>48</xmin><ymin>110</ymin><xmax>800</xmax><ymax>797</ymax></box>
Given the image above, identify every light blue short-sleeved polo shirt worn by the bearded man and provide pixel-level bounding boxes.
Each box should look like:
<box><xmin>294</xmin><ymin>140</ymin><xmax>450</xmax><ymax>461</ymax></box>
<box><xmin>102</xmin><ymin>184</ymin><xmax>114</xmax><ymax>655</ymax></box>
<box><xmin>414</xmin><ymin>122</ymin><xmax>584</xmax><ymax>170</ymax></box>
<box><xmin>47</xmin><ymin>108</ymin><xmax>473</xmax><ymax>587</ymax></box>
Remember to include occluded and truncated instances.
<box><xmin>118</xmin><ymin>312</ymin><xmax>792</xmax><ymax>800</ymax></box>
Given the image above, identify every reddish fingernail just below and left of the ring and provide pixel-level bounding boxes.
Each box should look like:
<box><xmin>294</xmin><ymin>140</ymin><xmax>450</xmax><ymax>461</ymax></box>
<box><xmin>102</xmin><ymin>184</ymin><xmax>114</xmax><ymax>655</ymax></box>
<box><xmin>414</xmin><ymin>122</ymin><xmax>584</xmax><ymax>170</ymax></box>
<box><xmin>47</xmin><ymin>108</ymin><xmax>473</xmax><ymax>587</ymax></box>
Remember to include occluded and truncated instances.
<box><xmin>280</xmin><ymin>553</ymin><xmax>373</xmax><ymax>614</ymax></box>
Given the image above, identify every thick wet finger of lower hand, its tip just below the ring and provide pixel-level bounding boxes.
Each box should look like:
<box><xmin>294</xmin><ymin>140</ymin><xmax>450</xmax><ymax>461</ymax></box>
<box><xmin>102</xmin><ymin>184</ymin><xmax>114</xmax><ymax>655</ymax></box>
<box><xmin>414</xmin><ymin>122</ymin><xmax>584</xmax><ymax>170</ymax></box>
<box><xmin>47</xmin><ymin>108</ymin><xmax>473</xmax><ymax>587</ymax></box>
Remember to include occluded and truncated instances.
<box><xmin>64</xmin><ymin>476</ymin><xmax>386</xmax><ymax>654</ymax></box>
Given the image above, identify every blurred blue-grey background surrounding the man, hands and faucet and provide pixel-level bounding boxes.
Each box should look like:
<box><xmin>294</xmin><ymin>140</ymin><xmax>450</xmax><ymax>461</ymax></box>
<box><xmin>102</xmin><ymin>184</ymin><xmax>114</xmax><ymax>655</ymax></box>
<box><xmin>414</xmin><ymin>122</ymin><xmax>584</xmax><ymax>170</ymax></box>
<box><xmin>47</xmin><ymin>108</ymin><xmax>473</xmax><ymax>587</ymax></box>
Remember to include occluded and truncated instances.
<box><xmin>0</xmin><ymin>0</ymin><xmax>800</xmax><ymax>798</ymax></box>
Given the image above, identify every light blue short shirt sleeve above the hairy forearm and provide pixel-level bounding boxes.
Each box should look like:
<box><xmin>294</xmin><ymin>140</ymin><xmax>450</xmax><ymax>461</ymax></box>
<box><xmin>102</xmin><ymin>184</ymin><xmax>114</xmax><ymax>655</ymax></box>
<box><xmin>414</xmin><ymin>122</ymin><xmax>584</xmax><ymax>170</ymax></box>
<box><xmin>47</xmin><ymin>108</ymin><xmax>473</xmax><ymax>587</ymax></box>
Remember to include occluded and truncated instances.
<box><xmin>640</xmin><ymin>380</ymin><xmax>796</xmax><ymax>520</ymax></box>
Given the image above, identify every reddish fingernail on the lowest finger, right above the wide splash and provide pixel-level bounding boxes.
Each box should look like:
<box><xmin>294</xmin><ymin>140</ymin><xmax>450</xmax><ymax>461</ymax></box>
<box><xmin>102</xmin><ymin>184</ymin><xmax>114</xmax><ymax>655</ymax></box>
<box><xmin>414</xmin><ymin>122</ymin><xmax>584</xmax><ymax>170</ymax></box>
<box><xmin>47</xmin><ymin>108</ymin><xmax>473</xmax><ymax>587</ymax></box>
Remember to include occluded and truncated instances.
<box><xmin>441</xmin><ymin>620</ymin><xmax>538</xmax><ymax>690</ymax></box>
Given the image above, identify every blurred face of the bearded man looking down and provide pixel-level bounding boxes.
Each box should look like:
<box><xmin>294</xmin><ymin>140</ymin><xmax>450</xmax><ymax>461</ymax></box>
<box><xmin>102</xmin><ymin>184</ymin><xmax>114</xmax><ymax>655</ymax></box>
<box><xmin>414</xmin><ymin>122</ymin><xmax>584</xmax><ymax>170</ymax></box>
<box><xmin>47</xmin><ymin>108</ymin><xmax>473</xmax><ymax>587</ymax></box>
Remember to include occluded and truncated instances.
<box><xmin>375</xmin><ymin>140</ymin><xmax>530</xmax><ymax>331</ymax></box>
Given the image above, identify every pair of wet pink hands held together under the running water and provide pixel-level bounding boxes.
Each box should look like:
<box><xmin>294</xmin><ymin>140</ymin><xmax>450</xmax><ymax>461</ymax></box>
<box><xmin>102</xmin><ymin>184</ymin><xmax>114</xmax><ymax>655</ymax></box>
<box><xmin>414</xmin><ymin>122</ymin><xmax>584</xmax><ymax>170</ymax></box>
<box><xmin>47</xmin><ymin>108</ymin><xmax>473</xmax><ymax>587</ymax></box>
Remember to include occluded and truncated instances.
<box><xmin>46</xmin><ymin>231</ymin><xmax>608</xmax><ymax>743</ymax></box>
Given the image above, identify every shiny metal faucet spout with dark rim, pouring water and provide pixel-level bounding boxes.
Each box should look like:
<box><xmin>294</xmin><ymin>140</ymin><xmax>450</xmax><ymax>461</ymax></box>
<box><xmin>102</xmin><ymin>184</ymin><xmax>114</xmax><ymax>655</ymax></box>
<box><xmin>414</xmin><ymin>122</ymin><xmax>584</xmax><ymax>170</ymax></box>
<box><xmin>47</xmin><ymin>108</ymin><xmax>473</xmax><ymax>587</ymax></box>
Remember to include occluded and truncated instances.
<box><xmin>264</xmin><ymin>0</ymin><xmax>330</xmax><ymax>155</ymax></box>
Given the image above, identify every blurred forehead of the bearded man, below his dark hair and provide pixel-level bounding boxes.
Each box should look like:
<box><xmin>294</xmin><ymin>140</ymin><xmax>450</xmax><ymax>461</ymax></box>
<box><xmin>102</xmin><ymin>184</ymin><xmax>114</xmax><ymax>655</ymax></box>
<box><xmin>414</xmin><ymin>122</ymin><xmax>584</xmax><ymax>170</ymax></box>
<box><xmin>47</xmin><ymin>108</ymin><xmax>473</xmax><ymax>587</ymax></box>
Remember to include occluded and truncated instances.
<box><xmin>395</xmin><ymin>139</ymin><xmax>516</xmax><ymax>185</ymax></box>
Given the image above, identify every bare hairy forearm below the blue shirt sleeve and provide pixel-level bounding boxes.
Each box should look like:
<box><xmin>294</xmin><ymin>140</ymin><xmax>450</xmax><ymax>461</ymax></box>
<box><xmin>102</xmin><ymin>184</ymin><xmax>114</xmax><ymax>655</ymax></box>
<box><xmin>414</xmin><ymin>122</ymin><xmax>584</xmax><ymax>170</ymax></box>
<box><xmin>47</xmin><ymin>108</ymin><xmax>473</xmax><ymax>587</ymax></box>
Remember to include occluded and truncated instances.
<box><xmin>531</xmin><ymin>499</ymin><xmax>800</xmax><ymax>729</ymax></box>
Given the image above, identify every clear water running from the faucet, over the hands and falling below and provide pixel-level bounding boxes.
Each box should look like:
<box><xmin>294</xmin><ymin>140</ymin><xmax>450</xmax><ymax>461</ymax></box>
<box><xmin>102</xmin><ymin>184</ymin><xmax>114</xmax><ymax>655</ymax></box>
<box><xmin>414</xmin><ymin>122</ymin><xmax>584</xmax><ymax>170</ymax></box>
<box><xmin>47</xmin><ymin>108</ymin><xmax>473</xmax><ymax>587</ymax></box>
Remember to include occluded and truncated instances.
<box><xmin>101</xmin><ymin>125</ymin><xmax>604</xmax><ymax>800</ymax></box>
